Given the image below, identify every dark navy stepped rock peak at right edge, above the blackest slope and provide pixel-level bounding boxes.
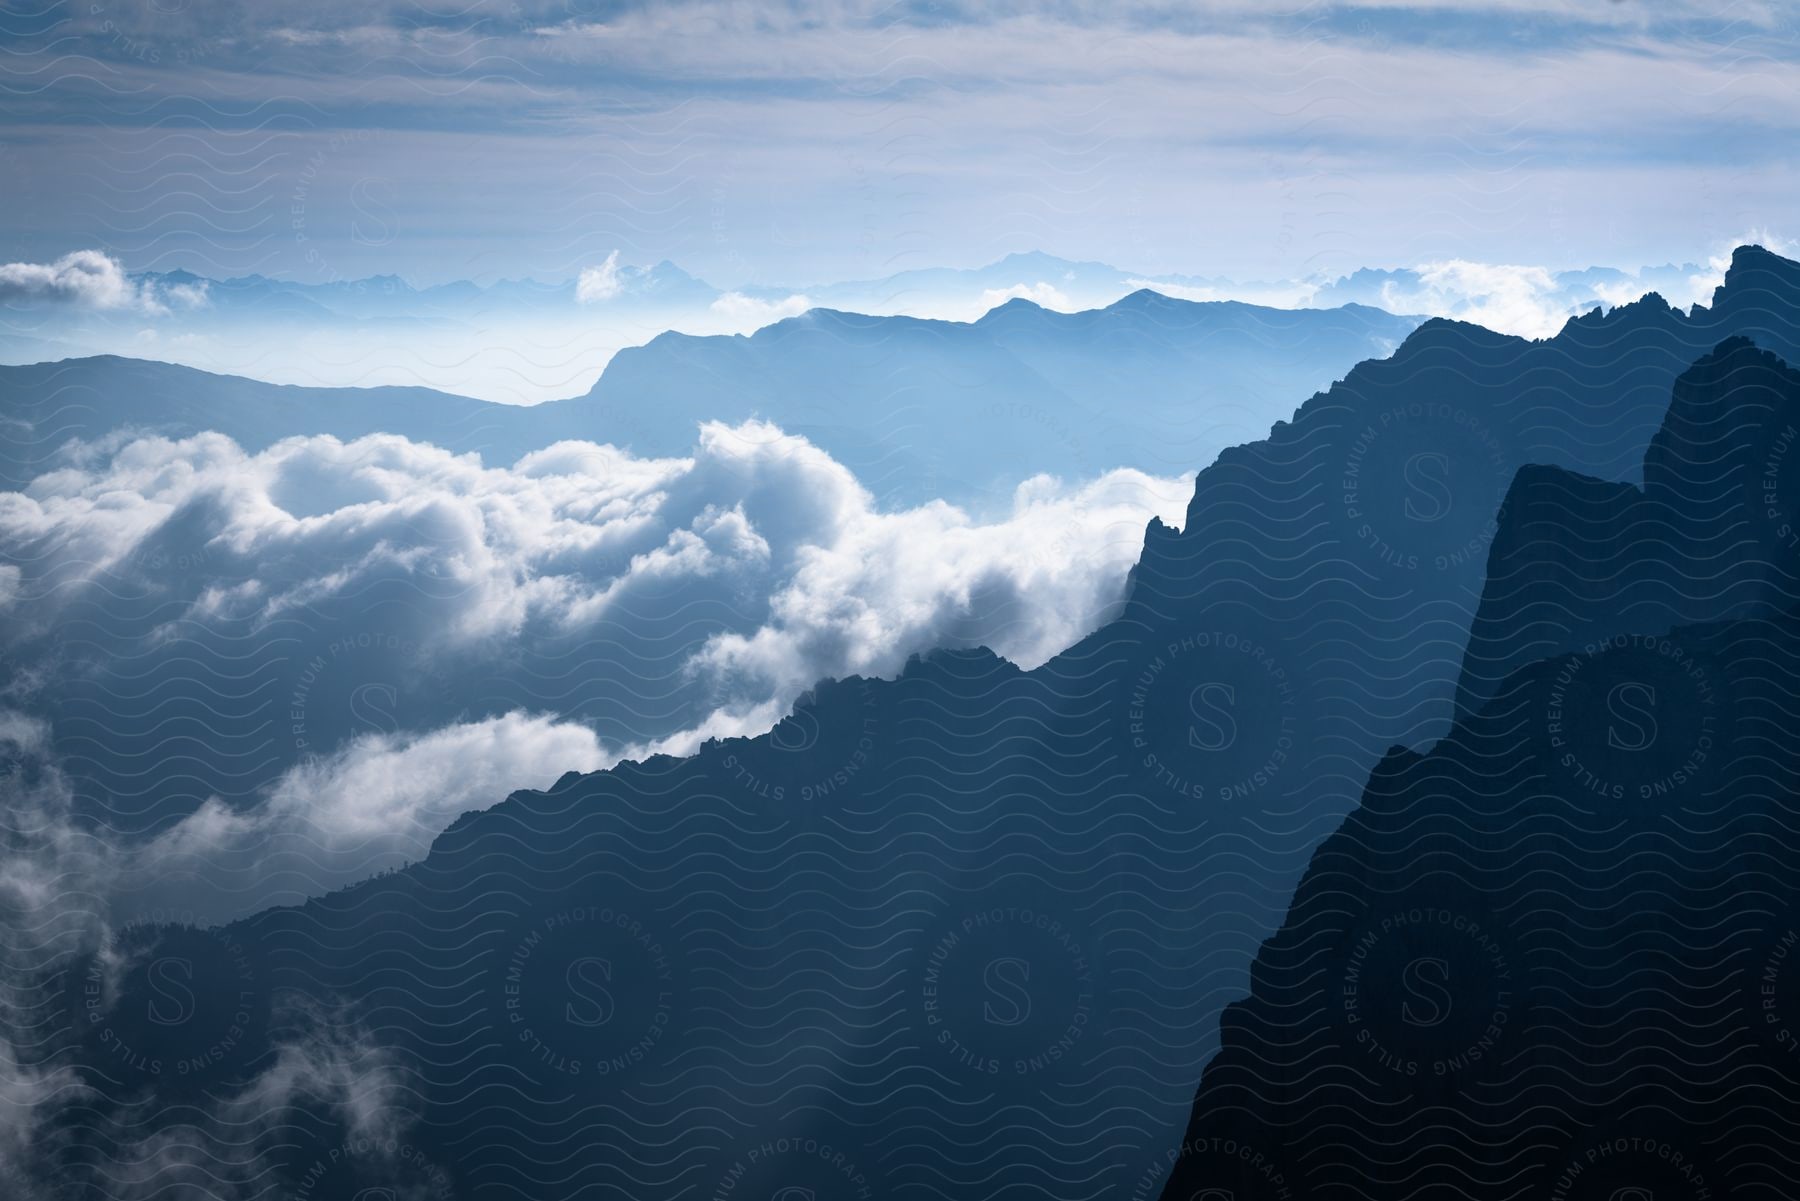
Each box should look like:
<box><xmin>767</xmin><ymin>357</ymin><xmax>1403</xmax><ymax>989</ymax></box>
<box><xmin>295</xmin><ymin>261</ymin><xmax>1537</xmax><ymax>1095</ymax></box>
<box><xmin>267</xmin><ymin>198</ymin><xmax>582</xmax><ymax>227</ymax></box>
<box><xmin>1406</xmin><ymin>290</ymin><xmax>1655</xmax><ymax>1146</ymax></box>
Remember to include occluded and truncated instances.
<box><xmin>1458</xmin><ymin>339</ymin><xmax>1800</xmax><ymax>713</ymax></box>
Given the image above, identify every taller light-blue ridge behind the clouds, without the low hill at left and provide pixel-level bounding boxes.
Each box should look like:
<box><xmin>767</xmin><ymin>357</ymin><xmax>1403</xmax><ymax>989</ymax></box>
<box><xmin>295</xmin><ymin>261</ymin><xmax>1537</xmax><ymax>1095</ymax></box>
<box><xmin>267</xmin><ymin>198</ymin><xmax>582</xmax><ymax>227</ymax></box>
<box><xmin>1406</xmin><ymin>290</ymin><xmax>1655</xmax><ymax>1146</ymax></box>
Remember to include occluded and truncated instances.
<box><xmin>580</xmin><ymin>292</ymin><xmax>1418</xmax><ymax>504</ymax></box>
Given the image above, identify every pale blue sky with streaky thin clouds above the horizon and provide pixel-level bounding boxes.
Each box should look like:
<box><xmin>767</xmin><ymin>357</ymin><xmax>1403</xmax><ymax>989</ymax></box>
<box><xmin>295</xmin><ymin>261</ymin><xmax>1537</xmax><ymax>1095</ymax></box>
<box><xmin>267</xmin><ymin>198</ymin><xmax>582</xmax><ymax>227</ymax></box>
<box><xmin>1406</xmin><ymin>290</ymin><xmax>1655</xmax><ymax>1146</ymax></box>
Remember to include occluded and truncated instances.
<box><xmin>0</xmin><ymin>0</ymin><xmax>1800</xmax><ymax>286</ymax></box>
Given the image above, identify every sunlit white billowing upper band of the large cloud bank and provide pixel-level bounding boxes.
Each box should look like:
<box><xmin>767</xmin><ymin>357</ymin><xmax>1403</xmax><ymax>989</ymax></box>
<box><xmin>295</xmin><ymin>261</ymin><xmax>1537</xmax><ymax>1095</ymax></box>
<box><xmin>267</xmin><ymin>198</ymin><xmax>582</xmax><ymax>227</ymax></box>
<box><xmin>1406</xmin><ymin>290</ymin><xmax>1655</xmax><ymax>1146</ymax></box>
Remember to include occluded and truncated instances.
<box><xmin>0</xmin><ymin>420</ymin><xmax>1190</xmax><ymax>673</ymax></box>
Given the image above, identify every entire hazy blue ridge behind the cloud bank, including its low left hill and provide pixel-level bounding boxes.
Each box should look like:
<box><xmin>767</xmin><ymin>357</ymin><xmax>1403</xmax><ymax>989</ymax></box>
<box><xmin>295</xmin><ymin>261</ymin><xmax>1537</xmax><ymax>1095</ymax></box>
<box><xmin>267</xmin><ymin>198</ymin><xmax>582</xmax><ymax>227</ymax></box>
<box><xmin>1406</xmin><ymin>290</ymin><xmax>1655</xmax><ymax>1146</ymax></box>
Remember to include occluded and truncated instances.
<box><xmin>0</xmin><ymin>292</ymin><xmax>1417</xmax><ymax>508</ymax></box>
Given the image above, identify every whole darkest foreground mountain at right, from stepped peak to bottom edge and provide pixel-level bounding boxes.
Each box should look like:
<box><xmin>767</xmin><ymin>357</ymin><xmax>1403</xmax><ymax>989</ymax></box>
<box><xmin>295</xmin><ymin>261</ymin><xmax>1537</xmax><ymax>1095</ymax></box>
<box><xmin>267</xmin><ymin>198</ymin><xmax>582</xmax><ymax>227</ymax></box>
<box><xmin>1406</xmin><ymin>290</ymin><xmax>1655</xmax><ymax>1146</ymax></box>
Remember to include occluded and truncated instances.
<box><xmin>1163</xmin><ymin>339</ymin><xmax>1800</xmax><ymax>1201</ymax></box>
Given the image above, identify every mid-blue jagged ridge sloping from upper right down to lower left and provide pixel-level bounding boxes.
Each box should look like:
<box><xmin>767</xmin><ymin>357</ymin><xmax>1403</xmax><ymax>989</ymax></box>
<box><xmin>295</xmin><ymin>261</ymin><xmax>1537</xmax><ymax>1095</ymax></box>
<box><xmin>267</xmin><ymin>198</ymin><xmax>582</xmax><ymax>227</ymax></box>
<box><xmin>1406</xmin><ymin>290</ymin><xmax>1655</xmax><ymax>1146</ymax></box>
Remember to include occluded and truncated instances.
<box><xmin>35</xmin><ymin>250</ymin><xmax>1800</xmax><ymax>1199</ymax></box>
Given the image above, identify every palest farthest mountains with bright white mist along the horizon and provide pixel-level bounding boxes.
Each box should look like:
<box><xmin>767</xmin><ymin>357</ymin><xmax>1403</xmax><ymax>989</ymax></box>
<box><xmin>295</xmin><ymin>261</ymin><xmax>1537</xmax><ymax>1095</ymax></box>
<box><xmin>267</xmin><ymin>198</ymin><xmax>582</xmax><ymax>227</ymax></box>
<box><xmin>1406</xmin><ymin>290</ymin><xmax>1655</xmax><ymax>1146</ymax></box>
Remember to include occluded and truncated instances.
<box><xmin>0</xmin><ymin>244</ymin><xmax>1717</xmax><ymax>403</ymax></box>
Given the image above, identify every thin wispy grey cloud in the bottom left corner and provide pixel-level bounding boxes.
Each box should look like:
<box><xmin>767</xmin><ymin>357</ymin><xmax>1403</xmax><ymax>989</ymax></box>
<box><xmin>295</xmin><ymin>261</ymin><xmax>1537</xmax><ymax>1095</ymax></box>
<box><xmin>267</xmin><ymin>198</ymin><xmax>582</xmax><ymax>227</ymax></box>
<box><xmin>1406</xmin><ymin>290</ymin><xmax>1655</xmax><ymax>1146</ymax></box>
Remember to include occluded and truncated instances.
<box><xmin>0</xmin><ymin>698</ymin><xmax>421</xmax><ymax>1201</ymax></box>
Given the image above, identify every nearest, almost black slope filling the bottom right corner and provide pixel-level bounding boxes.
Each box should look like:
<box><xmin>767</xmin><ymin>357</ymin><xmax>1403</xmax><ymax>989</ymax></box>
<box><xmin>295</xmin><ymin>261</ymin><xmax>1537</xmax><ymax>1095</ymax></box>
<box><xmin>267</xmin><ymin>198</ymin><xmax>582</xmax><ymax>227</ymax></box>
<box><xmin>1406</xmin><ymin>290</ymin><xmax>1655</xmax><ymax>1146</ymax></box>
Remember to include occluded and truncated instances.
<box><xmin>1138</xmin><ymin>614</ymin><xmax>1800</xmax><ymax>1201</ymax></box>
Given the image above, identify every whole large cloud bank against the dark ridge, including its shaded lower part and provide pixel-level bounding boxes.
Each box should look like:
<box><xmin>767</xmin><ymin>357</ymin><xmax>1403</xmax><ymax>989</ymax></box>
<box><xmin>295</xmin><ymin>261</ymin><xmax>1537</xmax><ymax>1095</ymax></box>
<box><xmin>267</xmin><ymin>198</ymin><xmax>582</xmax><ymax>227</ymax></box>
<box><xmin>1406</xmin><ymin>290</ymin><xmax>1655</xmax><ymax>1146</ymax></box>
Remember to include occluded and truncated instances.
<box><xmin>0</xmin><ymin>421</ymin><xmax>1192</xmax><ymax>917</ymax></box>
